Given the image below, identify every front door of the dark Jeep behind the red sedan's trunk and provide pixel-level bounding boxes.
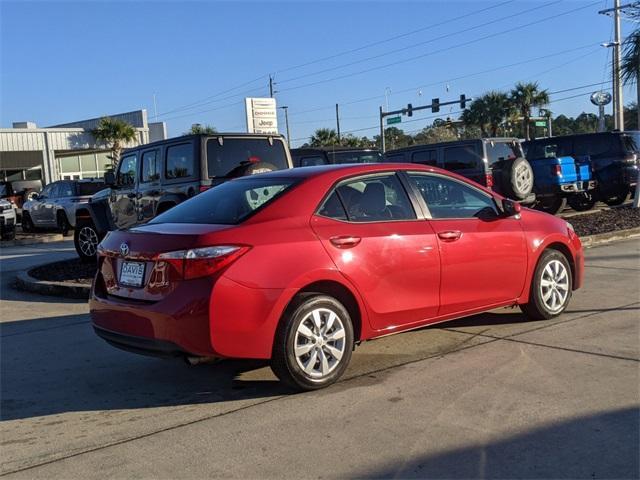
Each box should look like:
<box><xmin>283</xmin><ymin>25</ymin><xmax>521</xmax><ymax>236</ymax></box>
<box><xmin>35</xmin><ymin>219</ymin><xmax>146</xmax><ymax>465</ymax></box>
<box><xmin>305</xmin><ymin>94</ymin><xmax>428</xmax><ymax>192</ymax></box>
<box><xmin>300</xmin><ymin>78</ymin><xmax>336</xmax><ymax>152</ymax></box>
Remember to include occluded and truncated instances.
<box><xmin>109</xmin><ymin>152</ymin><xmax>138</xmax><ymax>228</ymax></box>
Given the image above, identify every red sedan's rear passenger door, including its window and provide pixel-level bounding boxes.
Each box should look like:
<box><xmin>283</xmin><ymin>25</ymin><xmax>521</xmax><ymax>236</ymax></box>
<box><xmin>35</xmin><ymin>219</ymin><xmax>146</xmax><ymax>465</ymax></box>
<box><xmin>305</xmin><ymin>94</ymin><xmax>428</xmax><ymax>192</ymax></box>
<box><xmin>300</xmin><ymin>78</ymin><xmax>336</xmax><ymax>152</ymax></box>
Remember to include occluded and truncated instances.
<box><xmin>311</xmin><ymin>173</ymin><xmax>440</xmax><ymax>332</ymax></box>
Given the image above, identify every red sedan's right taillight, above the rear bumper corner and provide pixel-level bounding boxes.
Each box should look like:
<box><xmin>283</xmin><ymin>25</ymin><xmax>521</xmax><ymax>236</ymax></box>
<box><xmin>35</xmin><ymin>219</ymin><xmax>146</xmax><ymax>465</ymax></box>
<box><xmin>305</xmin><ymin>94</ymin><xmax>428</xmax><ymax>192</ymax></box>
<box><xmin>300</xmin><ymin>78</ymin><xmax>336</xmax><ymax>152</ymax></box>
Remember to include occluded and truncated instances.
<box><xmin>156</xmin><ymin>245</ymin><xmax>249</xmax><ymax>280</ymax></box>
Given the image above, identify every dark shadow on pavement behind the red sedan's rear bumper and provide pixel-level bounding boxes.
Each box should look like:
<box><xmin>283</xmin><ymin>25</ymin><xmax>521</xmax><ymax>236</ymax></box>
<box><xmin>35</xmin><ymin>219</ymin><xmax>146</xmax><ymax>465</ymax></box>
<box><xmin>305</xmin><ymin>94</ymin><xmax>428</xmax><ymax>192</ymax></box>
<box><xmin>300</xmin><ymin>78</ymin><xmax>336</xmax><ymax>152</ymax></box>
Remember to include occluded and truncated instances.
<box><xmin>0</xmin><ymin>315</ymin><xmax>288</xmax><ymax>420</ymax></box>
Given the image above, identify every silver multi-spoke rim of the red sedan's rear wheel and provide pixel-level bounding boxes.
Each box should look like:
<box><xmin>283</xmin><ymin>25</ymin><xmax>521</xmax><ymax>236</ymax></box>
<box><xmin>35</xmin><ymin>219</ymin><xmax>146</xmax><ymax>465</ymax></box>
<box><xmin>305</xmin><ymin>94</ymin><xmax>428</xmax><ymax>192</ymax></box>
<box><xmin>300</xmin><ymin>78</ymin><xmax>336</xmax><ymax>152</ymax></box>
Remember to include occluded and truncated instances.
<box><xmin>294</xmin><ymin>308</ymin><xmax>346</xmax><ymax>379</ymax></box>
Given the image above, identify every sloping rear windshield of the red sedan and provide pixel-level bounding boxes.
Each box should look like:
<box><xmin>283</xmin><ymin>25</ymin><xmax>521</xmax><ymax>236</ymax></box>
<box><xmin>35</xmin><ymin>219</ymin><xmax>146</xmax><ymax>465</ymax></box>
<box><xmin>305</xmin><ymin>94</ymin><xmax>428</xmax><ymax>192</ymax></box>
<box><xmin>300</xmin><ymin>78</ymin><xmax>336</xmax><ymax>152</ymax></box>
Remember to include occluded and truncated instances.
<box><xmin>149</xmin><ymin>177</ymin><xmax>295</xmax><ymax>225</ymax></box>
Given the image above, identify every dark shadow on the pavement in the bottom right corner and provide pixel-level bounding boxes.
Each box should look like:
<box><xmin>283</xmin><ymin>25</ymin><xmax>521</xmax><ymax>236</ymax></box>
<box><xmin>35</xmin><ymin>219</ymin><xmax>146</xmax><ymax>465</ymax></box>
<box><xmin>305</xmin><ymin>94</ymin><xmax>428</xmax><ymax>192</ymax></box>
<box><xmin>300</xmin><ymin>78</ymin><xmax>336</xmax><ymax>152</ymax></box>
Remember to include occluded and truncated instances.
<box><xmin>358</xmin><ymin>407</ymin><xmax>640</xmax><ymax>479</ymax></box>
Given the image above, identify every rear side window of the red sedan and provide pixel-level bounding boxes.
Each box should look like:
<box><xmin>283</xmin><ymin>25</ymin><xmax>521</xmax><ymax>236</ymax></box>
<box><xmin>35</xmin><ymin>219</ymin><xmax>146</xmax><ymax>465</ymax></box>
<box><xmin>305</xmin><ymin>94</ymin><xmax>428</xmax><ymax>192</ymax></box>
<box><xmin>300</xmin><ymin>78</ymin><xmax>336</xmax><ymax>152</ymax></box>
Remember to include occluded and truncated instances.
<box><xmin>319</xmin><ymin>174</ymin><xmax>416</xmax><ymax>222</ymax></box>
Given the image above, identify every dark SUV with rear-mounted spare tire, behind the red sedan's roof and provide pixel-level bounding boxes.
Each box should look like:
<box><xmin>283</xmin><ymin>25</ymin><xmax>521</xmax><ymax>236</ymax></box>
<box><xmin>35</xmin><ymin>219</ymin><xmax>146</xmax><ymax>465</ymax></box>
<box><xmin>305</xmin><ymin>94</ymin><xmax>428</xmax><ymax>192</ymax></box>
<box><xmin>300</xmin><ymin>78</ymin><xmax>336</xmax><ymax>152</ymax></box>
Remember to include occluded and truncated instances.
<box><xmin>385</xmin><ymin>138</ymin><xmax>535</xmax><ymax>204</ymax></box>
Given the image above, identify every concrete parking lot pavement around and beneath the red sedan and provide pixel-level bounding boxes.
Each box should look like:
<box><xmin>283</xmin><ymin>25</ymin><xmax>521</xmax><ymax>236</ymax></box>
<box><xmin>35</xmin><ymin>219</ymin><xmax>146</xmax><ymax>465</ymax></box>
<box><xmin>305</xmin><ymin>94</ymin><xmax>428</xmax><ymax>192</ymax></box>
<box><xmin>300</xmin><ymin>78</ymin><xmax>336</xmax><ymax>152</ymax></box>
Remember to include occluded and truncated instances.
<box><xmin>0</xmin><ymin>240</ymin><xmax>640</xmax><ymax>478</ymax></box>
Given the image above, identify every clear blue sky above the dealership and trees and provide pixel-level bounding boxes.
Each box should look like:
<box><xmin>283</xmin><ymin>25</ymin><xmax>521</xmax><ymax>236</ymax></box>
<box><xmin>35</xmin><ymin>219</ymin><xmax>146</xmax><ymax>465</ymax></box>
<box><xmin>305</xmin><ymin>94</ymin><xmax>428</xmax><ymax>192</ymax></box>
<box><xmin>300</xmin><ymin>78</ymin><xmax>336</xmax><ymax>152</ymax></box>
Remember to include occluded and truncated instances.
<box><xmin>0</xmin><ymin>0</ymin><xmax>635</xmax><ymax>146</ymax></box>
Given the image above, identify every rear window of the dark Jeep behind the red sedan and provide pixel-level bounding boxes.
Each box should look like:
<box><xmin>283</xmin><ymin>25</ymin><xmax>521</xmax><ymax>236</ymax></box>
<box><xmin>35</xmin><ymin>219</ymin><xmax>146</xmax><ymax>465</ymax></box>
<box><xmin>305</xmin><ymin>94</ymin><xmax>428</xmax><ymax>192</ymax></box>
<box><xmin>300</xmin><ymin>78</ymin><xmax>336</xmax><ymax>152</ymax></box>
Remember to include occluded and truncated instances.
<box><xmin>207</xmin><ymin>138</ymin><xmax>289</xmax><ymax>178</ymax></box>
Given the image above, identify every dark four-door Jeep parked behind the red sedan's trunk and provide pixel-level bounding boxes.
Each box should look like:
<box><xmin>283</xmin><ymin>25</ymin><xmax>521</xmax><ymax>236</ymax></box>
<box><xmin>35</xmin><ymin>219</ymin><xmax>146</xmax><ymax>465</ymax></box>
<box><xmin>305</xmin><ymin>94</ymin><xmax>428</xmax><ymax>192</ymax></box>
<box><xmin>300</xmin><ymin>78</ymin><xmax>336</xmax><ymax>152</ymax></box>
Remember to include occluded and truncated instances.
<box><xmin>74</xmin><ymin>133</ymin><xmax>292</xmax><ymax>260</ymax></box>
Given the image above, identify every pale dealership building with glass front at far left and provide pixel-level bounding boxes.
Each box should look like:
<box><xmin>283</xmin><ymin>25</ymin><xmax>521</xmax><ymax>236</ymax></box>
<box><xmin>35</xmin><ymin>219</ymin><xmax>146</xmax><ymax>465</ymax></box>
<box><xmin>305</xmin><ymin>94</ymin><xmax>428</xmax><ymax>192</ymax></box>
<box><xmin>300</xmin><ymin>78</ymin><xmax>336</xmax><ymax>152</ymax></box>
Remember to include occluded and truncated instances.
<box><xmin>0</xmin><ymin>110</ymin><xmax>167</xmax><ymax>184</ymax></box>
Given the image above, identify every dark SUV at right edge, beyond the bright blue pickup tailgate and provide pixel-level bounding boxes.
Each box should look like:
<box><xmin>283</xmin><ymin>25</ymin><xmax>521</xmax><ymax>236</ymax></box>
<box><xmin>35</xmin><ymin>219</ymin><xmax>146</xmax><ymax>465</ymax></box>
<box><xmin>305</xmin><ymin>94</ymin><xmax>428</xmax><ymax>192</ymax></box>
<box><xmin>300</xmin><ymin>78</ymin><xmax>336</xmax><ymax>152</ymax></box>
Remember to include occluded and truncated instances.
<box><xmin>523</xmin><ymin>131</ymin><xmax>640</xmax><ymax>206</ymax></box>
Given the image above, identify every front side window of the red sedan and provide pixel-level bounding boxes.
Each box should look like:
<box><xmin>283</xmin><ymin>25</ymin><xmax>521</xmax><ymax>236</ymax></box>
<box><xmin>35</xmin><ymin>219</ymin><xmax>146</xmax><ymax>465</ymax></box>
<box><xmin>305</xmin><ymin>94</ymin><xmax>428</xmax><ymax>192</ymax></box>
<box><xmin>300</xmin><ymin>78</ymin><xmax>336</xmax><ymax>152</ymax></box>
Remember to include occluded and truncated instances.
<box><xmin>409</xmin><ymin>173</ymin><xmax>498</xmax><ymax>219</ymax></box>
